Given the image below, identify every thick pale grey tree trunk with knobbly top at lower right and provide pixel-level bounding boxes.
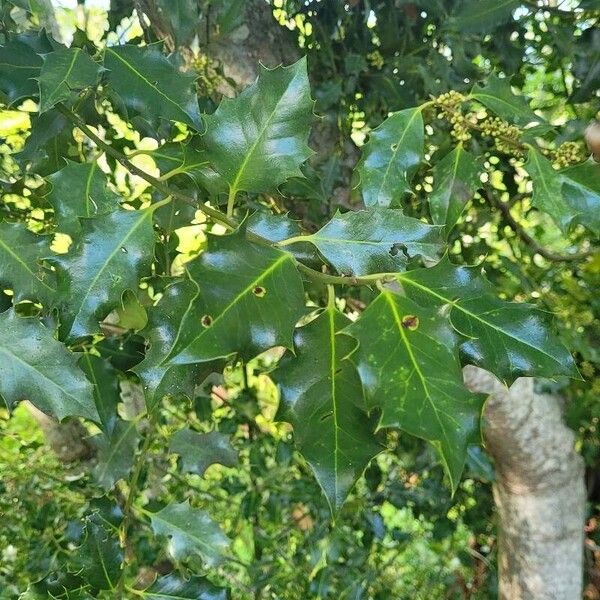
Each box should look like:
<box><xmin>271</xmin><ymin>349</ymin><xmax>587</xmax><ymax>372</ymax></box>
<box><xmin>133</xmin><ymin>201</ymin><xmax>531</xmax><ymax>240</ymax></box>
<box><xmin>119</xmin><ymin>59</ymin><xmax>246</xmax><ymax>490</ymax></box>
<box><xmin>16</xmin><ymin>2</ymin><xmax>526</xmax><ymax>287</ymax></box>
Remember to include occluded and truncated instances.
<box><xmin>464</xmin><ymin>366</ymin><xmax>586</xmax><ymax>600</ymax></box>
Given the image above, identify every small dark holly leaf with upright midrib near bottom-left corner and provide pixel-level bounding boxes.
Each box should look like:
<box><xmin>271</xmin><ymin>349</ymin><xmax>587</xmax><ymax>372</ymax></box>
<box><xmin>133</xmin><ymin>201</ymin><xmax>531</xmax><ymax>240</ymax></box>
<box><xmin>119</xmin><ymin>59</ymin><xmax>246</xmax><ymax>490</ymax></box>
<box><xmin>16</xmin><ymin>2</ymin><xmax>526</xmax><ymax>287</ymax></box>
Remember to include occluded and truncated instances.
<box><xmin>73</xmin><ymin>514</ymin><xmax>123</xmax><ymax>590</ymax></box>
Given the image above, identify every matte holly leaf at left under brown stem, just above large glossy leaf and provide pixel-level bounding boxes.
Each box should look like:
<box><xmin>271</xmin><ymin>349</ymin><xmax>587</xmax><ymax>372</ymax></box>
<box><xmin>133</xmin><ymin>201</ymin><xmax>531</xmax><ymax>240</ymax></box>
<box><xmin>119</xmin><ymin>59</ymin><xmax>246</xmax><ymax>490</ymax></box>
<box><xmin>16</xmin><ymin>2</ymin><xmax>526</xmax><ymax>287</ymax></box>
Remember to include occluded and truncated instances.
<box><xmin>46</xmin><ymin>161</ymin><xmax>119</xmax><ymax>238</ymax></box>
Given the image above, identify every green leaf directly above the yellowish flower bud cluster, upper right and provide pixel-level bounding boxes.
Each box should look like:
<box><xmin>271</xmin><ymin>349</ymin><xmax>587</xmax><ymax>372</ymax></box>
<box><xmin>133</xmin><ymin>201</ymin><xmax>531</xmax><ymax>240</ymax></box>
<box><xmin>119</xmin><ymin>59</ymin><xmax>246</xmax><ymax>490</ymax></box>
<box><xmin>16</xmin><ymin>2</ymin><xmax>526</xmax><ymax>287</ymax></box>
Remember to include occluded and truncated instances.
<box><xmin>471</xmin><ymin>75</ymin><xmax>544</xmax><ymax>125</ymax></box>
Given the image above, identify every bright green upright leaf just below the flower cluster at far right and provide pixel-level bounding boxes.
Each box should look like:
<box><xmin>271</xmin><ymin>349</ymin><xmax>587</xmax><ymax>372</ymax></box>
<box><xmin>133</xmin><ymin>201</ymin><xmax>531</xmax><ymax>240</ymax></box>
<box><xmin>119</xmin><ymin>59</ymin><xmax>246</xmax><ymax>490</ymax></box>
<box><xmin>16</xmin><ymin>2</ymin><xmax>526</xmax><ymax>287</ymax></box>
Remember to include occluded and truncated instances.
<box><xmin>525</xmin><ymin>148</ymin><xmax>577</xmax><ymax>233</ymax></box>
